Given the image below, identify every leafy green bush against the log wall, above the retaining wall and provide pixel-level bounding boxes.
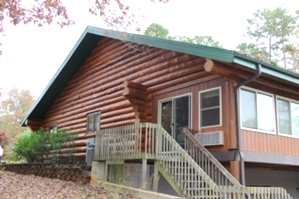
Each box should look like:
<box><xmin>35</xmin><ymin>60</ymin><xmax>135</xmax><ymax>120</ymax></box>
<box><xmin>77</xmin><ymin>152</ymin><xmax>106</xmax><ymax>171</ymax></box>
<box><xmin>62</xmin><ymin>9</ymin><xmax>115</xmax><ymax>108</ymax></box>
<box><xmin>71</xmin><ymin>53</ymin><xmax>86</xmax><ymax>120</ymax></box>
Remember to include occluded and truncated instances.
<box><xmin>13</xmin><ymin>129</ymin><xmax>74</xmax><ymax>162</ymax></box>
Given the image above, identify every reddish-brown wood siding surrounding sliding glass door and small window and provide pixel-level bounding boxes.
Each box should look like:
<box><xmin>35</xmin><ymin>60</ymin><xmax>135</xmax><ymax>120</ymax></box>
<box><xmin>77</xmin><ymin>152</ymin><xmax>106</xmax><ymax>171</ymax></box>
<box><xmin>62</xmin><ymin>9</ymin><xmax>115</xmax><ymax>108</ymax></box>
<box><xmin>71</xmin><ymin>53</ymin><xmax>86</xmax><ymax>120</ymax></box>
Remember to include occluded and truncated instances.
<box><xmin>153</xmin><ymin>75</ymin><xmax>237</xmax><ymax>150</ymax></box>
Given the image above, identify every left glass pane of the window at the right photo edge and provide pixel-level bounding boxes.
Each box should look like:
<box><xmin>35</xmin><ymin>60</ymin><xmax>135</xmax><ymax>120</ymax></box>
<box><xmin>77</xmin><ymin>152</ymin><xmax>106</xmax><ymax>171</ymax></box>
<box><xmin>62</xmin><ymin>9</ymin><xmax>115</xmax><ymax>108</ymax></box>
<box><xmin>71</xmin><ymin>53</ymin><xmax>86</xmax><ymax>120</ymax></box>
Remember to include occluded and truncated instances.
<box><xmin>277</xmin><ymin>99</ymin><xmax>291</xmax><ymax>135</ymax></box>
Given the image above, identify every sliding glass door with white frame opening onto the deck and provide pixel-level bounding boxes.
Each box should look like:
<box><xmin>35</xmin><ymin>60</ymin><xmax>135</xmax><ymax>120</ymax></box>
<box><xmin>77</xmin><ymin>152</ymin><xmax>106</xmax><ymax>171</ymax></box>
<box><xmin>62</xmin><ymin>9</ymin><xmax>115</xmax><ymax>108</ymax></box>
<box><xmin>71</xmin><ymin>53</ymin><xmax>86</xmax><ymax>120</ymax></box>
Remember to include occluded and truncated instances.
<box><xmin>159</xmin><ymin>95</ymin><xmax>191</xmax><ymax>147</ymax></box>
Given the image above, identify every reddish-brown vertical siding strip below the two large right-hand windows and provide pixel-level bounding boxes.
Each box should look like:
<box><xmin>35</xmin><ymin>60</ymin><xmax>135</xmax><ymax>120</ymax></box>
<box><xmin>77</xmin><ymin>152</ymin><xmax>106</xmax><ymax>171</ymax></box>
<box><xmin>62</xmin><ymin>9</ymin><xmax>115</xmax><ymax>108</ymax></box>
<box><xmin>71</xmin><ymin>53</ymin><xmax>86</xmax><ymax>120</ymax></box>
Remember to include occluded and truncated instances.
<box><xmin>242</xmin><ymin>130</ymin><xmax>299</xmax><ymax>156</ymax></box>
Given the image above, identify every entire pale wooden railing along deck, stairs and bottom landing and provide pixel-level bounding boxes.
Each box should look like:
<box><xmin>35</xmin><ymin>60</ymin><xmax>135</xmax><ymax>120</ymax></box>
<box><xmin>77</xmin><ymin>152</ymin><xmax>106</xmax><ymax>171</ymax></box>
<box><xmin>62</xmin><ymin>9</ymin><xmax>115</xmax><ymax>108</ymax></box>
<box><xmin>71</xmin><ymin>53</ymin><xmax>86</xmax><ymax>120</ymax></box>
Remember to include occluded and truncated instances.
<box><xmin>95</xmin><ymin>123</ymin><xmax>292</xmax><ymax>199</ymax></box>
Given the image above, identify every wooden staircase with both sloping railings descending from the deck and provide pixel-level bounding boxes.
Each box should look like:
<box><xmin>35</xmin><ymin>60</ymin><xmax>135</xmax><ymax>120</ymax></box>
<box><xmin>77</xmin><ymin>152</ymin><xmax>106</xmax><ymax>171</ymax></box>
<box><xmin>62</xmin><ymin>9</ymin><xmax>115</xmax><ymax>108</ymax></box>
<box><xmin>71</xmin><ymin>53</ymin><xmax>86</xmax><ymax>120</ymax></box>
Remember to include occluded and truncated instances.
<box><xmin>156</xmin><ymin>126</ymin><xmax>234</xmax><ymax>199</ymax></box>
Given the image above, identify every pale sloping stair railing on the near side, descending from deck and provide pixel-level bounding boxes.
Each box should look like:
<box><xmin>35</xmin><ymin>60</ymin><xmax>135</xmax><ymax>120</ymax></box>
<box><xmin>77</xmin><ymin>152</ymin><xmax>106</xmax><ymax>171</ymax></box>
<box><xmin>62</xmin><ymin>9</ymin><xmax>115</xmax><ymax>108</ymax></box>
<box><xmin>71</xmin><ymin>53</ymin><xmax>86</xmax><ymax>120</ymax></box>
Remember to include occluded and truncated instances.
<box><xmin>156</xmin><ymin>125</ymin><xmax>219</xmax><ymax>199</ymax></box>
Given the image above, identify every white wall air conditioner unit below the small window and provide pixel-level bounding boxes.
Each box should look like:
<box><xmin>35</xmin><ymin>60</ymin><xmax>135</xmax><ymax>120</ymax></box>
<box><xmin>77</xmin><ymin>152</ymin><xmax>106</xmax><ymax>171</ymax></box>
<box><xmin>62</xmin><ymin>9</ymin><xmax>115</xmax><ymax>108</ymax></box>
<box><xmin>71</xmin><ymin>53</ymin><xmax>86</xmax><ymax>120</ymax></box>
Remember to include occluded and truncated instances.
<box><xmin>195</xmin><ymin>131</ymin><xmax>224</xmax><ymax>146</ymax></box>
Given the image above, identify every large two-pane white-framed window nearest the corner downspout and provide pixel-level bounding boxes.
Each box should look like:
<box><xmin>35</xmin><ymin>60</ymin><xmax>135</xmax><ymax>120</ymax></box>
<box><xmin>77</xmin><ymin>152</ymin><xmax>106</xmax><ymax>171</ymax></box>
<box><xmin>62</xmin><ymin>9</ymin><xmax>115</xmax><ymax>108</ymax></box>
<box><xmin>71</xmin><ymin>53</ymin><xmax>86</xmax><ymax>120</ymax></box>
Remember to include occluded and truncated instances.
<box><xmin>241</xmin><ymin>88</ymin><xmax>274</xmax><ymax>132</ymax></box>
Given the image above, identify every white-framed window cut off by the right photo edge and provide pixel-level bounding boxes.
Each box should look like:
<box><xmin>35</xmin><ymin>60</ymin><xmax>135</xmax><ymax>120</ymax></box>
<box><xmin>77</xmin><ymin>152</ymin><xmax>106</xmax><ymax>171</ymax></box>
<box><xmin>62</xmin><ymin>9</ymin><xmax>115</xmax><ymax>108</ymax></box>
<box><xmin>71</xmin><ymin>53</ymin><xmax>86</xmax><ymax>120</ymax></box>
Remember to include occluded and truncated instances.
<box><xmin>277</xmin><ymin>98</ymin><xmax>299</xmax><ymax>137</ymax></box>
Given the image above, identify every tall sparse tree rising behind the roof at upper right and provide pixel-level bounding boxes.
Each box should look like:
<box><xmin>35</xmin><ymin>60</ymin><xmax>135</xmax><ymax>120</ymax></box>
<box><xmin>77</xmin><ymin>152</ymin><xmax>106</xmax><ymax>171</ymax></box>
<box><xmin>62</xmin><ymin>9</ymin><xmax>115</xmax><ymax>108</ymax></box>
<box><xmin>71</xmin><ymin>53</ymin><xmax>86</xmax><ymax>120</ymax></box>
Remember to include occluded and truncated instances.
<box><xmin>237</xmin><ymin>7</ymin><xmax>298</xmax><ymax>69</ymax></box>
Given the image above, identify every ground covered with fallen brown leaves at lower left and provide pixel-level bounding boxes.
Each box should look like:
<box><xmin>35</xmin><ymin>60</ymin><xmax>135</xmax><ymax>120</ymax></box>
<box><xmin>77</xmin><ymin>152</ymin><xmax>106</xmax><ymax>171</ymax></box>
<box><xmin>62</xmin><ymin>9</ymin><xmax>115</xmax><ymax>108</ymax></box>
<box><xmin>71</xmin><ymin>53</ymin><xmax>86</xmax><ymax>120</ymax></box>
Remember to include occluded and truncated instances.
<box><xmin>0</xmin><ymin>170</ymin><xmax>140</xmax><ymax>199</ymax></box>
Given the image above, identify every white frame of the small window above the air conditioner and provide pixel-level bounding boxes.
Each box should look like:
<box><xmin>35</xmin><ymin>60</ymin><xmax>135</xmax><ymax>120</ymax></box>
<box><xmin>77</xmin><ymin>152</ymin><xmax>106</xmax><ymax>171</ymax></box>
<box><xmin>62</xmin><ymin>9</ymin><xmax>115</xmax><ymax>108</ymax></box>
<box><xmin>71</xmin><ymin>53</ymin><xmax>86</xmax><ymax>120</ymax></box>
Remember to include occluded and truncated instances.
<box><xmin>198</xmin><ymin>86</ymin><xmax>222</xmax><ymax>129</ymax></box>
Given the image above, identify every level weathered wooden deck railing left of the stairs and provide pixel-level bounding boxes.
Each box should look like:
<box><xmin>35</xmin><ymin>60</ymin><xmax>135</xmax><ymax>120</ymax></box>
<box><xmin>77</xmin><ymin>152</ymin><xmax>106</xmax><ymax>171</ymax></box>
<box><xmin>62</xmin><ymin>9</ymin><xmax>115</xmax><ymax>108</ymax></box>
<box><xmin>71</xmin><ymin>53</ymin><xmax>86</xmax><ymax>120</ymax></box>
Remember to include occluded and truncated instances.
<box><xmin>94</xmin><ymin>123</ymin><xmax>157</xmax><ymax>160</ymax></box>
